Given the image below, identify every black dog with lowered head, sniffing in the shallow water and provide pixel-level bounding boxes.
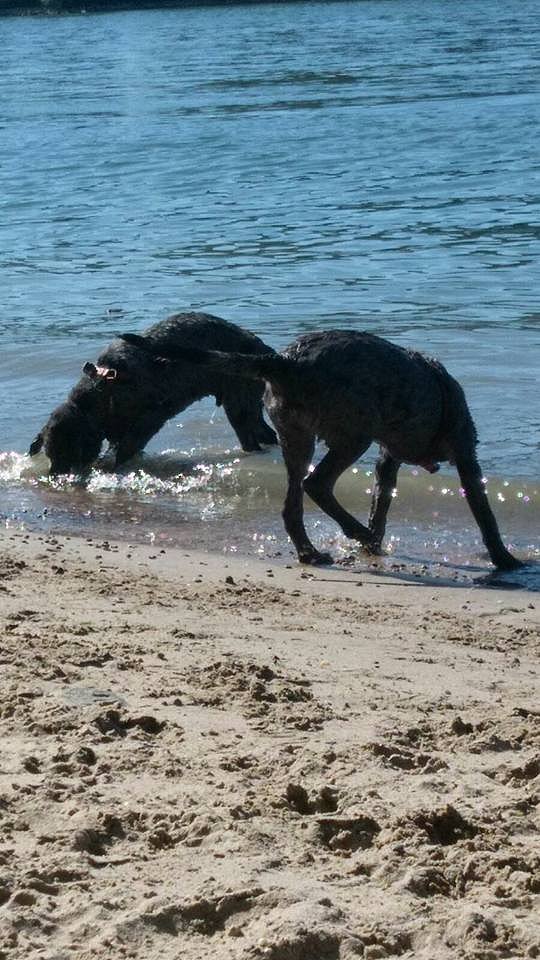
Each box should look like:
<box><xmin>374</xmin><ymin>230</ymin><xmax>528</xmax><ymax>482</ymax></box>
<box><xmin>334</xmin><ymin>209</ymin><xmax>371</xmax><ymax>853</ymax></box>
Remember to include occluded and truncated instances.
<box><xmin>29</xmin><ymin>313</ymin><xmax>276</xmax><ymax>475</ymax></box>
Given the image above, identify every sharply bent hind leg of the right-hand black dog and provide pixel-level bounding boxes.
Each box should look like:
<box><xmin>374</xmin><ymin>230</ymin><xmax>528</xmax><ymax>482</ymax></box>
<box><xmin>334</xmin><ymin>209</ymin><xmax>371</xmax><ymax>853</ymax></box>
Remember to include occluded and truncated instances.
<box><xmin>304</xmin><ymin>437</ymin><xmax>373</xmax><ymax>546</ymax></box>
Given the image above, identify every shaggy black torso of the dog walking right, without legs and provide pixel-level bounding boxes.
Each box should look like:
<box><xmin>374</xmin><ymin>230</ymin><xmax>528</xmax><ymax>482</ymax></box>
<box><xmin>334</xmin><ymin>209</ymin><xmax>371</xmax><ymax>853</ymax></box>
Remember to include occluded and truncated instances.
<box><xmin>270</xmin><ymin>330</ymin><xmax>476</xmax><ymax>463</ymax></box>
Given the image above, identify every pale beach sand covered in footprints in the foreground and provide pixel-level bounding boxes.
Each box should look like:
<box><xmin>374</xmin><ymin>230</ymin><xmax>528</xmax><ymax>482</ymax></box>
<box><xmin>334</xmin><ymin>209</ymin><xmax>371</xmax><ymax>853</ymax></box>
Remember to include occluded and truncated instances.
<box><xmin>0</xmin><ymin>530</ymin><xmax>540</xmax><ymax>960</ymax></box>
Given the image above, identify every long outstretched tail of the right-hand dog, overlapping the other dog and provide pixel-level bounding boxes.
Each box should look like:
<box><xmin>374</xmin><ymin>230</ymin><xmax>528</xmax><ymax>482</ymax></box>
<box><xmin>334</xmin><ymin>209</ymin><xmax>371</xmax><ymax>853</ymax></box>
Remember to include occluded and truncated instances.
<box><xmin>117</xmin><ymin>333</ymin><xmax>297</xmax><ymax>383</ymax></box>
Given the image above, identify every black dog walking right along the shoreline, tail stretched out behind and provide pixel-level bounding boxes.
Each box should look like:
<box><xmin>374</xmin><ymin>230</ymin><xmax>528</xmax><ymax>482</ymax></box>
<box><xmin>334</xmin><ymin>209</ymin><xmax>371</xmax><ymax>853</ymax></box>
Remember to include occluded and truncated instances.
<box><xmin>118</xmin><ymin>330</ymin><xmax>521</xmax><ymax>570</ymax></box>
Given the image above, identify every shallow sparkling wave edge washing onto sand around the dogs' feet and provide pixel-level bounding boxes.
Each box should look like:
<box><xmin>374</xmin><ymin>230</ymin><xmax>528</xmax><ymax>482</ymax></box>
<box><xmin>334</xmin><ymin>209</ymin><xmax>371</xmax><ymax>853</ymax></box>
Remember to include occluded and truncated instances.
<box><xmin>0</xmin><ymin>451</ymin><xmax>540</xmax><ymax>593</ymax></box>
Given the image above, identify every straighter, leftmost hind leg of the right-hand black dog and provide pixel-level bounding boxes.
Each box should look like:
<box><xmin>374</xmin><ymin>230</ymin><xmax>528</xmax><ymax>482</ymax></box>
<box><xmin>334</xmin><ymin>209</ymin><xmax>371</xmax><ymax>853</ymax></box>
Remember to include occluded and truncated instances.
<box><xmin>280</xmin><ymin>429</ymin><xmax>332</xmax><ymax>564</ymax></box>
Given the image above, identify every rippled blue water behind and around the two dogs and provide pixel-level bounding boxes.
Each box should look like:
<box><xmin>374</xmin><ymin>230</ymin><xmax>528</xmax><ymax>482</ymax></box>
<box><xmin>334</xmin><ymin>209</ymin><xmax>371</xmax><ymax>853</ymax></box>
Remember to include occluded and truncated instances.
<box><xmin>0</xmin><ymin>0</ymin><xmax>540</xmax><ymax>584</ymax></box>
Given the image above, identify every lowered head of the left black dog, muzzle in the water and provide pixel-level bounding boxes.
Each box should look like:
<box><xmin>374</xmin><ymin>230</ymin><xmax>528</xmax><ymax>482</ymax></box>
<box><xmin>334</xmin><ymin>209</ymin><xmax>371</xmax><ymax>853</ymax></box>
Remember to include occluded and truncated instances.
<box><xmin>28</xmin><ymin>402</ymin><xmax>102</xmax><ymax>476</ymax></box>
